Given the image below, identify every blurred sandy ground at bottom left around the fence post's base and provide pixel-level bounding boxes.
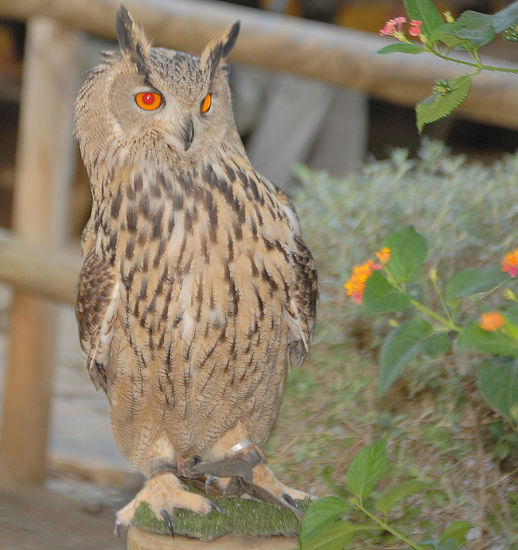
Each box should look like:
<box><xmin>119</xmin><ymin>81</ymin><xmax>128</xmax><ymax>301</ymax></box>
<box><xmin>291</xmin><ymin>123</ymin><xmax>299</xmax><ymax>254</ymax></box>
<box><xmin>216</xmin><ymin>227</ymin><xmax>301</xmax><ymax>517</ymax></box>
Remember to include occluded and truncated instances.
<box><xmin>0</xmin><ymin>286</ymin><xmax>140</xmax><ymax>550</ymax></box>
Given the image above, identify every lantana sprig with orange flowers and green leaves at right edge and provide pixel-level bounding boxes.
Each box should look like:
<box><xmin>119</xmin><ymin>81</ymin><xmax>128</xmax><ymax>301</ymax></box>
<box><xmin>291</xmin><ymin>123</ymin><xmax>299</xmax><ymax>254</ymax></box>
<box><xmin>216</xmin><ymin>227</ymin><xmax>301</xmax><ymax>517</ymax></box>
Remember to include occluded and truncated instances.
<box><xmin>346</xmin><ymin>226</ymin><xmax>518</xmax><ymax>423</ymax></box>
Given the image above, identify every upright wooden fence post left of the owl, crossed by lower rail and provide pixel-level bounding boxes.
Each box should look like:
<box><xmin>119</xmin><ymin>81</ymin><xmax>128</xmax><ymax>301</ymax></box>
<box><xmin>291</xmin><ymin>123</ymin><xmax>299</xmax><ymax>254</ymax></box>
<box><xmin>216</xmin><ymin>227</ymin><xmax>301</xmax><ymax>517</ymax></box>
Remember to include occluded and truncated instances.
<box><xmin>0</xmin><ymin>17</ymin><xmax>78</xmax><ymax>483</ymax></box>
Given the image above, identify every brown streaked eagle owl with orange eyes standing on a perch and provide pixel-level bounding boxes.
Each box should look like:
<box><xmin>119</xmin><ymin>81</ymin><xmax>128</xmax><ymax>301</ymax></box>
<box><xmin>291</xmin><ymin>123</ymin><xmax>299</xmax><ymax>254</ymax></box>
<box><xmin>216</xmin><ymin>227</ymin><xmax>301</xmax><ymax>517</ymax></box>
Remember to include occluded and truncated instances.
<box><xmin>75</xmin><ymin>7</ymin><xmax>317</xmax><ymax>536</ymax></box>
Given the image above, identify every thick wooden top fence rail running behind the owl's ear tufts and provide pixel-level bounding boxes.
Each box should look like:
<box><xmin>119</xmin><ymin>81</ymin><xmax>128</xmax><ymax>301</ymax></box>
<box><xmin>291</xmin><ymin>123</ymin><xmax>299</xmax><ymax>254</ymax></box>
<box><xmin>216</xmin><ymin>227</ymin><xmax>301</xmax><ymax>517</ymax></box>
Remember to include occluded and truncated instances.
<box><xmin>0</xmin><ymin>0</ymin><xmax>518</xmax><ymax>128</ymax></box>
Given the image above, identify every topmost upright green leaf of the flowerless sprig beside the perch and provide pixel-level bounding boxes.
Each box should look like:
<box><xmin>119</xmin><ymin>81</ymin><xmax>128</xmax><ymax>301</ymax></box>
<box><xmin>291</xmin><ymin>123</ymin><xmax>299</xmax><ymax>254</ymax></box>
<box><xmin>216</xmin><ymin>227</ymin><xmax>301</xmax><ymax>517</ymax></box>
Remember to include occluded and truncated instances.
<box><xmin>347</xmin><ymin>439</ymin><xmax>388</xmax><ymax>500</ymax></box>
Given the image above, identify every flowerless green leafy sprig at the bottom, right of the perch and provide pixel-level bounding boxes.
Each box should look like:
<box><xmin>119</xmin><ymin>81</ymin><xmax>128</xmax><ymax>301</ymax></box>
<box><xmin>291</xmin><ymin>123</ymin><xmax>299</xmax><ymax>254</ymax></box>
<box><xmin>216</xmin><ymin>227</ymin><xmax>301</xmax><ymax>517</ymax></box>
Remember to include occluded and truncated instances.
<box><xmin>299</xmin><ymin>439</ymin><xmax>471</xmax><ymax>550</ymax></box>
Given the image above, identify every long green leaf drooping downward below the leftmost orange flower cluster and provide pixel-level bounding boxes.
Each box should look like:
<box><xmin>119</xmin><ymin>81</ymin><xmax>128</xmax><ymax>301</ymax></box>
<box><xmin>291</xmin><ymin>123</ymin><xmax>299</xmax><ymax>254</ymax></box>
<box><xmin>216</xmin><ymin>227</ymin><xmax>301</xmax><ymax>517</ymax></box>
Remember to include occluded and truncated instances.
<box><xmin>378</xmin><ymin>318</ymin><xmax>433</xmax><ymax>397</ymax></box>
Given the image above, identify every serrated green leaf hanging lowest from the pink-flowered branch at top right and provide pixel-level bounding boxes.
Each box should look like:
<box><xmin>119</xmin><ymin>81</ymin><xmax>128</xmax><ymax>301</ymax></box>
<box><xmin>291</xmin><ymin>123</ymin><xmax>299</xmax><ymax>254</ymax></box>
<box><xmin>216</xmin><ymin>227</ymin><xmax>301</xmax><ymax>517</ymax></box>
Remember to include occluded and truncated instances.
<box><xmin>415</xmin><ymin>74</ymin><xmax>473</xmax><ymax>133</ymax></box>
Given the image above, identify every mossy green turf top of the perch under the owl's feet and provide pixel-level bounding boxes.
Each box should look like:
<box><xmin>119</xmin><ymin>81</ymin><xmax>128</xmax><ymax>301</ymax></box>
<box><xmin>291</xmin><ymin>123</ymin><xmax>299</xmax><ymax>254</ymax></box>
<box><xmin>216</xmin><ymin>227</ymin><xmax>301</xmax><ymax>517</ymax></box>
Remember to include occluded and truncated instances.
<box><xmin>133</xmin><ymin>497</ymin><xmax>311</xmax><ymax>541</ymax></box>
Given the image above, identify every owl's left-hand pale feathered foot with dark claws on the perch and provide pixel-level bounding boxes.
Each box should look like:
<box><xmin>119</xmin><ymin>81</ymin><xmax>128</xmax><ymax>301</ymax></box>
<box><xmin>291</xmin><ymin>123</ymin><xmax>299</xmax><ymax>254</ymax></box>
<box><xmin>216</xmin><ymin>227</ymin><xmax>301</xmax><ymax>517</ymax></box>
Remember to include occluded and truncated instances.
<box><xmin>115</xmin><ymin>472</ymin><xmax>218</xmax><ymax>537</ymax></box>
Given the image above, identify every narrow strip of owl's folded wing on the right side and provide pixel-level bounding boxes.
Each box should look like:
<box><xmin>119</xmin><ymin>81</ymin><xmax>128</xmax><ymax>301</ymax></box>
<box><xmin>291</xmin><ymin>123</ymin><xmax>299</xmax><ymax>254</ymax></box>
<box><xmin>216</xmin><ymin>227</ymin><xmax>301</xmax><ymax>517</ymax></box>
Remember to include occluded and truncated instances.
<box><xmin>276</xmin><ymin>189</ymin><xmax>318</xmax><ymax>365</ymax></box>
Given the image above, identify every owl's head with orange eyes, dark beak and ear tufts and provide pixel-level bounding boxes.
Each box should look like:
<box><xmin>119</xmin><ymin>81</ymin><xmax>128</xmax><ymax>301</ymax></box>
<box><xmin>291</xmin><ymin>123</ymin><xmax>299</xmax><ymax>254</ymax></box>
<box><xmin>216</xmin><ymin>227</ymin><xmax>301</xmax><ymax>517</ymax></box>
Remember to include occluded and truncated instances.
<box><xmin>75</xmin><ymin>6</ymin><xmax>239</xmax><ymax>172</ymax></box>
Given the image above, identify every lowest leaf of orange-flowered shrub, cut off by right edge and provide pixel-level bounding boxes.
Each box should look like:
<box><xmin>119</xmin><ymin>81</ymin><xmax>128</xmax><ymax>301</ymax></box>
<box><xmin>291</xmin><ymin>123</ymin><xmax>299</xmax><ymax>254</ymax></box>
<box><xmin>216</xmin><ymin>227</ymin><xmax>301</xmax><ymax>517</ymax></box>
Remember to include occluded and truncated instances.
<box><xmin>477</xmin><ymin>359</ymin><xmax>518</xmax><ymax>422</ymax></box>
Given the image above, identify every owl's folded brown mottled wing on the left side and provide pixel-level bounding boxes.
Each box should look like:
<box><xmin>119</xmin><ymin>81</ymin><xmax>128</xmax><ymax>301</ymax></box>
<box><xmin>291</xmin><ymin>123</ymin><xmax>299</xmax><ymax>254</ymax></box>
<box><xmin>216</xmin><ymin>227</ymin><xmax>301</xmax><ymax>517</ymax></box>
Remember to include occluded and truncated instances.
<box><xmin>76</xmin><ymin>249</ymin><xmax>119</xmax><ymax>391</ymax></box>
